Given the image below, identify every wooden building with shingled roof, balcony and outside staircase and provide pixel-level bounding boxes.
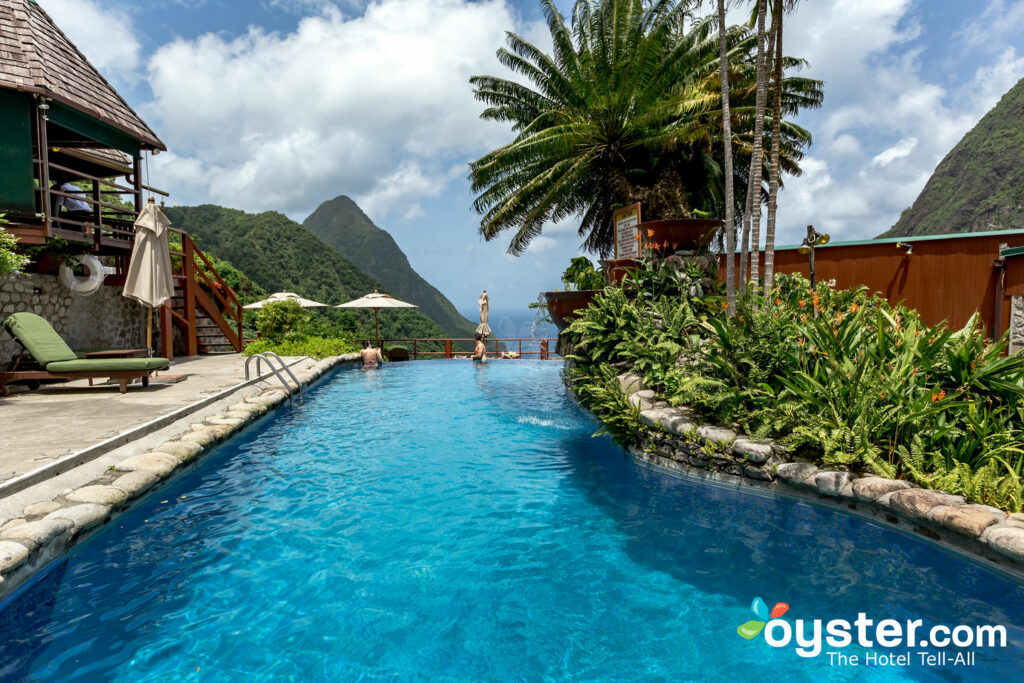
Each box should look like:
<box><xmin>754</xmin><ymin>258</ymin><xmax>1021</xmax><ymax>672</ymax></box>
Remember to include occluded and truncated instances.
<box><xmin>0</xmin><ymin>0</ymin><xmax>242</xmax><ymax>355</ymax></box>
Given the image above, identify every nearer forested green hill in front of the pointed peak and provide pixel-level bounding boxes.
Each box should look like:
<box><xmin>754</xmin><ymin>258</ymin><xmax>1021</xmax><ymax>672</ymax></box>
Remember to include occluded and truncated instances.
<box><xmin>165</xmin><ymin>204</ymin><xmax>446</xmax><ymax>339</ymax></box>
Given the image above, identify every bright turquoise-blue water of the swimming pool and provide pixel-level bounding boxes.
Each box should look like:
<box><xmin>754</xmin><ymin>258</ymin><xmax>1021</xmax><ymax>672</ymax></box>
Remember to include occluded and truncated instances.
<box><xmin>0</xmin><ymin>361</ymin><xmax>1024</xmax><ymax>683</ymax></box>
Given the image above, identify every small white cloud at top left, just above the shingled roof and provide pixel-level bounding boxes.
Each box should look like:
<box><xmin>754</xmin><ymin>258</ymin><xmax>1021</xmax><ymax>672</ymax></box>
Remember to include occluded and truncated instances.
<box><xmin>40</xmin><ymin>0</ymin><xmax>141</xmax><ymax>83</ymax></box>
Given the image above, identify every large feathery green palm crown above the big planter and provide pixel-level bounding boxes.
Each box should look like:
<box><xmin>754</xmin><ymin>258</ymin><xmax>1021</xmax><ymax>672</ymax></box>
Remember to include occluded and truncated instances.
<box><xmin>470</xmin><ymin>0</ymin><xmax>820</xmax><ymax>255</ymax></box>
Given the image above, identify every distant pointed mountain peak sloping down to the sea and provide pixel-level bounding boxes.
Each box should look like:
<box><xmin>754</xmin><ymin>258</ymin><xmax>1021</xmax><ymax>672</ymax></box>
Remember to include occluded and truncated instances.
<box><xmin>302</xmin><ymin>195</ymin><xmax>476</xmax><ymax>337</ymax></box>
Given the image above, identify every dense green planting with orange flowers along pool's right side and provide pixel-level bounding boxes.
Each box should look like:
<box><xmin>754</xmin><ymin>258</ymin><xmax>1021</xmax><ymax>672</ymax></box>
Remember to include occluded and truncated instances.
<box><xmin>569</xmin><ymin>275</ymin><xmax>1024</xmax><ymax>511</ymax></box>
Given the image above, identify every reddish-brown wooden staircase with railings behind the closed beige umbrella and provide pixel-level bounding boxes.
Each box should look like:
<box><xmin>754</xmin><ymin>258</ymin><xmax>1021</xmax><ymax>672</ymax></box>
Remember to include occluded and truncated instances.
<box><xmin>162</xmin><ymin>227</ymin><xmax>243</xmax><ymax>357</ymax></box>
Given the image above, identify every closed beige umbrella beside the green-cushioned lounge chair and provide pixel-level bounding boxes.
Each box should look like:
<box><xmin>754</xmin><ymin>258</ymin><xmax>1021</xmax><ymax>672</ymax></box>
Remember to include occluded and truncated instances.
<box><xmin>122</xmin><ymin>197</ymin><xmax>174</xmax><ymax>356</ymax></box>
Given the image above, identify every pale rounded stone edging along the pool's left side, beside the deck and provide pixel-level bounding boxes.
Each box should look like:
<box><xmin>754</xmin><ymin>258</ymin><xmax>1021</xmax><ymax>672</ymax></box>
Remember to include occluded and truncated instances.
<box><xmin>0</xmin><ymin>353</ymin><xmax>359</xmax><ymax>601</ymax></box>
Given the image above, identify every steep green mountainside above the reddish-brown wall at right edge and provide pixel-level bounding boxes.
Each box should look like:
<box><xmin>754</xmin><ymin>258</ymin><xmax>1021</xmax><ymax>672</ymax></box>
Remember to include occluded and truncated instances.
<box><xmin>879</xmin><ymin>79</ymin><xmax>1024</xmax><ymax>238</ymax></box>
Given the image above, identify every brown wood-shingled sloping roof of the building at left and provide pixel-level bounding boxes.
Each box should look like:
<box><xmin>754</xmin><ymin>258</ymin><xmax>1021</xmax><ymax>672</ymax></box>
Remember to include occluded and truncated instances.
<box><xmin>0</xmin><ymin>0</ymin><xmax>167</xmax><ymax>150</ymax></box>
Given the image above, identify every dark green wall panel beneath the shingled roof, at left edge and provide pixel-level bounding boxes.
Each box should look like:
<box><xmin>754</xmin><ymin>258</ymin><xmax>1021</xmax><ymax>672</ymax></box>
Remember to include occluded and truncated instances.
<box><xmin>0</xmin><ymin>90</ymin><xmax>36</xmax><ymax>215</ymax></box>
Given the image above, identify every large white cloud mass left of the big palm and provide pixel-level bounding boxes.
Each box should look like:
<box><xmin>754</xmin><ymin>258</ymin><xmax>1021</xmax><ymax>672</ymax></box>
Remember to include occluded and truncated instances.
<box><xmin>146</xmin><ymin>0</ymin><xmax>540</xmax><ymax>218</ymax></box>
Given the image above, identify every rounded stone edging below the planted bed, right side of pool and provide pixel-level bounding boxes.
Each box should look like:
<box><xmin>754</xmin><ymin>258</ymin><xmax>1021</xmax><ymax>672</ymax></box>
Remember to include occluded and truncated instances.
<box><xmin>617</xmin><ymin>373</ymin><xmax>1024</xmax><ymax>582</ymax></box>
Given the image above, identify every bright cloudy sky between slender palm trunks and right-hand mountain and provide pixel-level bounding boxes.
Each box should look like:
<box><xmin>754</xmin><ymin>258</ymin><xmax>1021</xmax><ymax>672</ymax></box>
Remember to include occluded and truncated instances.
<box><xmin>776</xmin><ymin>0</ymin><xmax>1024</xmax><ymax>244</ymax></box>
